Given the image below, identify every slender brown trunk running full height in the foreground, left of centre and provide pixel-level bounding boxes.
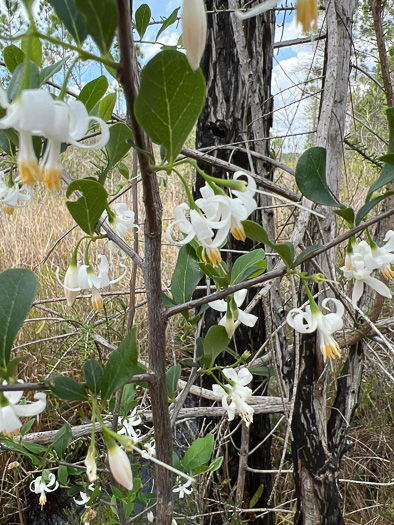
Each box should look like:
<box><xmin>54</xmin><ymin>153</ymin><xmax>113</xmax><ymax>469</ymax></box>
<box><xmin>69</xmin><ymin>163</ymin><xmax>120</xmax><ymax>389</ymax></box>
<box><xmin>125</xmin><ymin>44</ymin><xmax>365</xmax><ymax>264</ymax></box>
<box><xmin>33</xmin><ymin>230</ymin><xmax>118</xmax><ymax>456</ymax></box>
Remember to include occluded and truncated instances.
<box><xmin>118</xmin><ymin>0</ymin><xmax>172</xmax><ymax>525</ymax></box>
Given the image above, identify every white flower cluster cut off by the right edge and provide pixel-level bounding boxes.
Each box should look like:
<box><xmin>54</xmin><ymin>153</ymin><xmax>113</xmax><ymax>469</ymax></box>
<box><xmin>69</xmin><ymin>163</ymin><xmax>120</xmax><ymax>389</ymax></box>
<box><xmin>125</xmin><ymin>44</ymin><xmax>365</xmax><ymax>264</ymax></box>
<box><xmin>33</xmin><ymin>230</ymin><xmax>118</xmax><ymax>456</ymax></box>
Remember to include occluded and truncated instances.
<box><xmin>341</xmin><ymin>230</ymin><xmax>394</xmax><ymax>306</ymax></box>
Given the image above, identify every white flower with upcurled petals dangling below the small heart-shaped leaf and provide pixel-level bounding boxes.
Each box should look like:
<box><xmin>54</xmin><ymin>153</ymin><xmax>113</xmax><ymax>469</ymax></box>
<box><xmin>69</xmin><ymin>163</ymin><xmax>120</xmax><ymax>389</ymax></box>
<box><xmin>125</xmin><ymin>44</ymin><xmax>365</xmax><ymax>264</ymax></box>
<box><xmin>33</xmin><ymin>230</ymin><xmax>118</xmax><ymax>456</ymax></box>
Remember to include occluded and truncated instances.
<box><xmin>56</xmin><ymin>255</ymin><xmax>127</xmax><ymax>310</ymax></box>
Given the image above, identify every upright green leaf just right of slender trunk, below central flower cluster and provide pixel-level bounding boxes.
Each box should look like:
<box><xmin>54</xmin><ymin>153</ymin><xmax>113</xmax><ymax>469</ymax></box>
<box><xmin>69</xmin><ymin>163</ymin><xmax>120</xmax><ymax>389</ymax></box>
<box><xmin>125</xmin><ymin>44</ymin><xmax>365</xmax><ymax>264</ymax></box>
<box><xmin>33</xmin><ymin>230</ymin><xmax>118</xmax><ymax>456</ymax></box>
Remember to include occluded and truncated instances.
<box><xmin>171</xmin><ymin>244</ymin><xmax>204</xmax><ymax>304</ymax></box>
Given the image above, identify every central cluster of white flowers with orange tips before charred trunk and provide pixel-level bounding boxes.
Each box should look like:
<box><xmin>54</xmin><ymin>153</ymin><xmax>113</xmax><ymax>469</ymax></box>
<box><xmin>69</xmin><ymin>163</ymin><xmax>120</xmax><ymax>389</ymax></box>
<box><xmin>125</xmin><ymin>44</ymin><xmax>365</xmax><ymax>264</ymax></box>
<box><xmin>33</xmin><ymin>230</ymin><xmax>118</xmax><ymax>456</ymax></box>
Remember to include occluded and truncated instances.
<box><xmin>166</xmin><ymin>171</ymin><xmax>257</xmax><ymax>266</ymax></box>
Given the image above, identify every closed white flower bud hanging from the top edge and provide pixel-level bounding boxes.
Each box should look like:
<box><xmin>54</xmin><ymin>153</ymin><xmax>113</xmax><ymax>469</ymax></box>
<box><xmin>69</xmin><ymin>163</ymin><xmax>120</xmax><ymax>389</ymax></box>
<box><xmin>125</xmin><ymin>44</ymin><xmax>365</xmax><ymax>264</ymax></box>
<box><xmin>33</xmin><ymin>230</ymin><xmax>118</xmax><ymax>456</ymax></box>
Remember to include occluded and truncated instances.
<box><xmin>182</xmin><ymin>0</ymin><xmax>207</xmax><ymax>71</ymax></box>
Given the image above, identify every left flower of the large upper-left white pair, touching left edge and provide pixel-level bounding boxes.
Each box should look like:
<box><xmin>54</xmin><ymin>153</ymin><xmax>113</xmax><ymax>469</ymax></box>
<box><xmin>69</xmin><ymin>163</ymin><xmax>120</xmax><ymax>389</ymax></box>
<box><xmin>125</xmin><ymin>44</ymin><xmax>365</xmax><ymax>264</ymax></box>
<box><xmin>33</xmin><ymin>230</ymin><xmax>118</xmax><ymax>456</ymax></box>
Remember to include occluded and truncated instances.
<box><xmin>0</xmin><ymin>88</ymin><xmax>53</xmax><ymax>186</ymax></box>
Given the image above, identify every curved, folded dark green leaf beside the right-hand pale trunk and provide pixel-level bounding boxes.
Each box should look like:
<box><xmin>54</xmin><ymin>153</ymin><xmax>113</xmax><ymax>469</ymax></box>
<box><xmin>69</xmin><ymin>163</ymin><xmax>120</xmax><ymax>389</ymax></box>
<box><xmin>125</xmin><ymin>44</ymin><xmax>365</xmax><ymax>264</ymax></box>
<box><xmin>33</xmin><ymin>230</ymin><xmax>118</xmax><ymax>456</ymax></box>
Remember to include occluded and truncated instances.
<box><xmin>295</xmin><ymin>146</ymin><xmax>343</xmax><ymax>207</ymax></box>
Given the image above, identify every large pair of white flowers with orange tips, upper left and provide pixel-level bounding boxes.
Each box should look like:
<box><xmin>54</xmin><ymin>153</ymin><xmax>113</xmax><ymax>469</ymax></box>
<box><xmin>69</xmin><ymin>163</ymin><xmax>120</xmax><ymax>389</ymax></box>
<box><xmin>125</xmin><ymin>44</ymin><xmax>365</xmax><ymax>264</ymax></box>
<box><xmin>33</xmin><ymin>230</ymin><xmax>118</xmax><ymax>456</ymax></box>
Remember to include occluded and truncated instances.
<box><xmin>0</xmin><ymin>87</ymin><xmax>109</xmax><ymax>194</ymax></box>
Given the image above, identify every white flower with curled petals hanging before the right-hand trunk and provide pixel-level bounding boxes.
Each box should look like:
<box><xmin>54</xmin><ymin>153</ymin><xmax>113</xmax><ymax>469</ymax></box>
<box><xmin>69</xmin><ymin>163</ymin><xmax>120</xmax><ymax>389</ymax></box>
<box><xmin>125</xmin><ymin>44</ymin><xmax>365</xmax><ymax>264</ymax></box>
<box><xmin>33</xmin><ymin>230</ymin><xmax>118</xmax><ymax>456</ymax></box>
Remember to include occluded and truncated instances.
<box><xmin>286</xmin><ymin>297</ymin><xmax>345</xmax><ymax>362</ymax></box>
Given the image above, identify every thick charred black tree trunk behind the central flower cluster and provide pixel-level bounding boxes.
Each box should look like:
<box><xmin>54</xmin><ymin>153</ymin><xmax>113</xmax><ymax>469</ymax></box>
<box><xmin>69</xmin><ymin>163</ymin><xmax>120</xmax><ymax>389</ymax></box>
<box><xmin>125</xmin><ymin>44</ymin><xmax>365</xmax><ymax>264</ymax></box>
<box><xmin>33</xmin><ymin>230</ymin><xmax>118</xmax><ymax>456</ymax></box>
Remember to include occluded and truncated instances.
<box><xmin>196</xmin><ymin>0</ymin><xmax>275</xmax><ymax>525</ymax></box>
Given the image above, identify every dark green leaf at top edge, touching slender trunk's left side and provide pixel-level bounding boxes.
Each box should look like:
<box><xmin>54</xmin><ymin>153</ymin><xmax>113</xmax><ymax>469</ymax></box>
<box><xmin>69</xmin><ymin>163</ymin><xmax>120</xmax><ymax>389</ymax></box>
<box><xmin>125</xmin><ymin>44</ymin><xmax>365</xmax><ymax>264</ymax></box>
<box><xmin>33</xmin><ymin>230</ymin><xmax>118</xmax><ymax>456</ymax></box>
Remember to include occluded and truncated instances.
<box><xmin>76</xmin><ymin>0</ymin><xmax>118</xmax><ymax>55</ymax></box>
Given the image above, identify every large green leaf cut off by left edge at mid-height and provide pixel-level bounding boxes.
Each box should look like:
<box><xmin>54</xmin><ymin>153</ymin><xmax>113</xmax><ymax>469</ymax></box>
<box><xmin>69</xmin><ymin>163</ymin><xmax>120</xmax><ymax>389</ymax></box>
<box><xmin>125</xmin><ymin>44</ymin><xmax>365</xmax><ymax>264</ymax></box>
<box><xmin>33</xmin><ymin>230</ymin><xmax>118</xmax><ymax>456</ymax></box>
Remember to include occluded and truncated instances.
<box><xmin>0</xmin><ymin>268</ymin><xmax>37</xmax><ymax>368</ymax></box>
